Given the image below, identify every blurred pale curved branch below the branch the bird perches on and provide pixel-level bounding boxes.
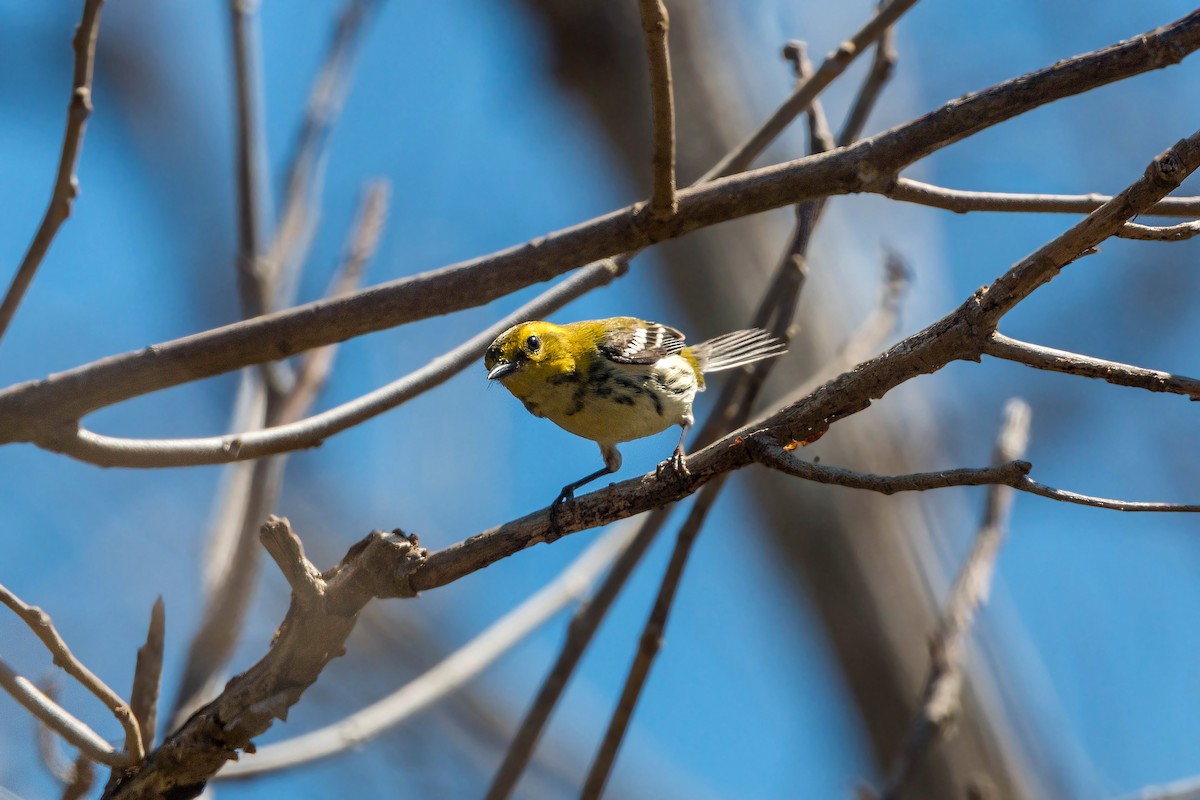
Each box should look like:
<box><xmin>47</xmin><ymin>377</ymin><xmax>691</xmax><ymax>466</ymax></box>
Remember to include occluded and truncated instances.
<box><xmin>217</xmin><ymin>525</ymin><xmax>636</xmax><ymax>778</ymax></box>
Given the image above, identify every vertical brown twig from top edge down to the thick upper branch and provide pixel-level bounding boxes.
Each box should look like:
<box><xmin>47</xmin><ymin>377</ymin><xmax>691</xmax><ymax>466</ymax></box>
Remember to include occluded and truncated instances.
<box><xmin>637</xmin><ymin>0</ymin><xmax>679</xmax><ymax>219</ymax></box>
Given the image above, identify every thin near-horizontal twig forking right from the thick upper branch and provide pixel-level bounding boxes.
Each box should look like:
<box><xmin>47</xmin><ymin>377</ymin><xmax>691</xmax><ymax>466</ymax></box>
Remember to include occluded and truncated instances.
<box><xmin>882</xmin><ymin>178</ymin><xmax>1200</xmax><ymax>217</ymax></box>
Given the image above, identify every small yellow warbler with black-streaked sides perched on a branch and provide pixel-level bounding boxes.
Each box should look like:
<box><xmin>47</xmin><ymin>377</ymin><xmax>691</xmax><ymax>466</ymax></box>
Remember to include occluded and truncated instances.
<box><xmin>484</xmin><ymin>317</ymin><xmax>787</xmax><ymax>510</ymax></box>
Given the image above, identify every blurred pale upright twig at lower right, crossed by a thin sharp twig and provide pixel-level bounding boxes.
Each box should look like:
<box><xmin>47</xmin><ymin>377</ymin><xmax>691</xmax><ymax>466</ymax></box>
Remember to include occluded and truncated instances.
<box><xmin>882</xmin><ymin>399</ymin><xmax>1031</xmax><ymax>800</ymax></box>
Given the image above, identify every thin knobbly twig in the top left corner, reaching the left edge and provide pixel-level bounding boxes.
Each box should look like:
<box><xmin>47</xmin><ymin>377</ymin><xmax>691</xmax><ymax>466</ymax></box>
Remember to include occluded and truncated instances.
<box><xmin>0</xmin><ymin>0</ymin><xmax>104</xmax><ymax>338</ymax></box>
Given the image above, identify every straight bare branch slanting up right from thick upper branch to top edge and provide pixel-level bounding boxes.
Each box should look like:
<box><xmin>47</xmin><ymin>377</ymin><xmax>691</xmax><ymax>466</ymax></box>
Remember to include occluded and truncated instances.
<box><xmin>704</xmin><ymin>0</ymin><xmax>917</xmax><ymax>180</ymax></box>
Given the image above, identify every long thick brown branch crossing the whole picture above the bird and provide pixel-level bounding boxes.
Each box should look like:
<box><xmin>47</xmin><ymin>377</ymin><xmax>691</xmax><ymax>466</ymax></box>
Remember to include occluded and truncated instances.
<box><xmin>0</xmin><ymin>6</ymin><xmax>1200</xmax><ymax>449</ymax></box>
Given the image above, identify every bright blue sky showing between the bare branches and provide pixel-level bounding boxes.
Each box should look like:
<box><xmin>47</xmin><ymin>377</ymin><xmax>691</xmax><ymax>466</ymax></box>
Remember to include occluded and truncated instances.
<box><xmin>0</xmin><ymin>0</ymin><xmax>1200</xmax><ymax>798</ymax></box>
